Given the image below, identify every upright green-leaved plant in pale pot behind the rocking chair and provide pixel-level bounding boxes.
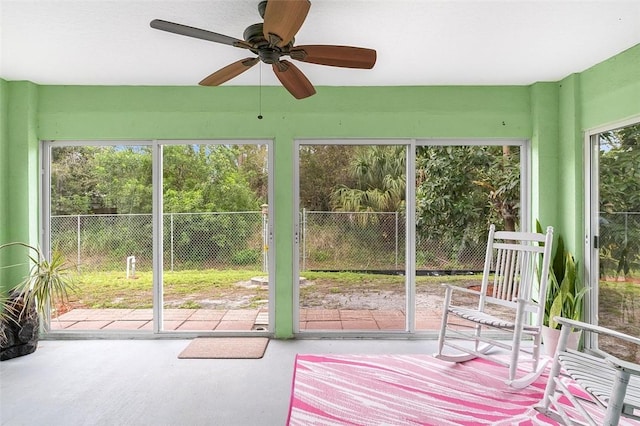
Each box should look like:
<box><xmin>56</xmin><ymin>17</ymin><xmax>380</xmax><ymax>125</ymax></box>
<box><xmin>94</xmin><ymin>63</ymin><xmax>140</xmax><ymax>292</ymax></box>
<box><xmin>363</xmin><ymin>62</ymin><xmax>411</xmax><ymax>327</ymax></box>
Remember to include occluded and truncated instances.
<box><xmin>542</xmin><ymin>230</ymin><xmax>589</xmax><ymax>356</ymax></box>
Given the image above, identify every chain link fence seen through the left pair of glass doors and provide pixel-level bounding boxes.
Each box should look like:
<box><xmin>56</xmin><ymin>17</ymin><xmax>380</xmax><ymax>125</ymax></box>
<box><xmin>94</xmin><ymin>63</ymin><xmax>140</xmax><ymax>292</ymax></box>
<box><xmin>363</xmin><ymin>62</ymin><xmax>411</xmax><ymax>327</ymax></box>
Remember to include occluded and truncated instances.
<box><xmin>51</xmin><ymin>212</ymin><xmax>267</xmax><ymax>271</ymax></box>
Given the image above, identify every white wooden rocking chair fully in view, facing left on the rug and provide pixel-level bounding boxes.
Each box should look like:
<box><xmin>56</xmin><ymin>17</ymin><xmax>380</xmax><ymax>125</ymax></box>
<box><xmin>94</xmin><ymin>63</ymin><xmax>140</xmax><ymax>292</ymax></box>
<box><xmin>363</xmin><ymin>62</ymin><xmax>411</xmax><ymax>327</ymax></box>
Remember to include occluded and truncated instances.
<box><xmin>434</xmin><ymin>225</ymin><xmax>553</xmax><ymax>389</ymax></box>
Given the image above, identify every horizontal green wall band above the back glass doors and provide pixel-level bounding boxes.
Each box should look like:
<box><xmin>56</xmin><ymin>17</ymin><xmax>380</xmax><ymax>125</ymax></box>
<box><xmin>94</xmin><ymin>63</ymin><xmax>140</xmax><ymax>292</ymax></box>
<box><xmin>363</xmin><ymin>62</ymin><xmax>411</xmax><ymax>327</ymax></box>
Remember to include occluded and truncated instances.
<box><xmin>38</xmin><ymin>86</ymin><xmax>530</xmax><ymax>140</ymax></box>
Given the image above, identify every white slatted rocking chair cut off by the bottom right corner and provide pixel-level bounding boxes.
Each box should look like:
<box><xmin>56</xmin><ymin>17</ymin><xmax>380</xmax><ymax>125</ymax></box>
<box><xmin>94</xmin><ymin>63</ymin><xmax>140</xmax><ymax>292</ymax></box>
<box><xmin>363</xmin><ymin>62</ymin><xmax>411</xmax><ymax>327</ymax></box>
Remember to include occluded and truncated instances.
<box><xmin>536</xmin><ymin>317</ymin><xmax>640</xmax><ymax>426</ymax></box>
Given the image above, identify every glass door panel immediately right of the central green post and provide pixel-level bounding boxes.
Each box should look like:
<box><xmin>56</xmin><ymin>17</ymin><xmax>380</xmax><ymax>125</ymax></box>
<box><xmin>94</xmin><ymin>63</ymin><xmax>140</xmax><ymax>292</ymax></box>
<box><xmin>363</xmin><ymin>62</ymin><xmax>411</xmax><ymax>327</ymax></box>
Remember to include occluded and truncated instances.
<box><xmin>296</xmin><ymin>141</ymin><xmax>407</xmax><ymax>333</ymax></box>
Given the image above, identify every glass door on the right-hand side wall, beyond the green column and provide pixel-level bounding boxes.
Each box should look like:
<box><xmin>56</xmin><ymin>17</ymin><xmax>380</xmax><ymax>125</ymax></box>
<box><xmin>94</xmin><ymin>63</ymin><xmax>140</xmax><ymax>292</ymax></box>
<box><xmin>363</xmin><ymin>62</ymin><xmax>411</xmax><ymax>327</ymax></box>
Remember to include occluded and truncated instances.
<box><xmin>589</xmin><ymin>123</ymin><xmax>640</xmax><ymax>362</ymax></box>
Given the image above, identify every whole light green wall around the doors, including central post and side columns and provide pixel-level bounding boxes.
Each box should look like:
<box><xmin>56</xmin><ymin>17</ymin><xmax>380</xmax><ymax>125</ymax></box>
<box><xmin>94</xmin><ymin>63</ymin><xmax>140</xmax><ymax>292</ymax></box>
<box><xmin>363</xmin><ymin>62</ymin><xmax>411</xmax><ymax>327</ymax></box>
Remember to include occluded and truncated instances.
<box><xmin>0</xmin><ymin>45</ymin><xmax>640</xmax><ymax>338</ymax></box>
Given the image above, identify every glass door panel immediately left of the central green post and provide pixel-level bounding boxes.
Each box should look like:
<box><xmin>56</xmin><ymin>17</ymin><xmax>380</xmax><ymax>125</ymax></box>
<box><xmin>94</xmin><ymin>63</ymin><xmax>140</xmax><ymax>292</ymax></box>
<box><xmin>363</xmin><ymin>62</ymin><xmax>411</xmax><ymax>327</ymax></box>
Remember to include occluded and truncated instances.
<box><xmin>162</xmin><ymin>143</ymin><xmax>269</xmax><ymax>331</ymax></box>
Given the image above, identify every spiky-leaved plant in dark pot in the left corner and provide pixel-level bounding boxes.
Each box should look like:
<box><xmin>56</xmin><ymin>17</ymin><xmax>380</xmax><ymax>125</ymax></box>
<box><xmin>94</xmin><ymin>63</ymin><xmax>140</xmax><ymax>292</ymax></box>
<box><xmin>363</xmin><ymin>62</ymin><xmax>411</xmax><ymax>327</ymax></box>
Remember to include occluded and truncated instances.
<box><xmin>0</xmin><ymin>242</ymin><xmax>75</xmax><ymax>361</ymax></box>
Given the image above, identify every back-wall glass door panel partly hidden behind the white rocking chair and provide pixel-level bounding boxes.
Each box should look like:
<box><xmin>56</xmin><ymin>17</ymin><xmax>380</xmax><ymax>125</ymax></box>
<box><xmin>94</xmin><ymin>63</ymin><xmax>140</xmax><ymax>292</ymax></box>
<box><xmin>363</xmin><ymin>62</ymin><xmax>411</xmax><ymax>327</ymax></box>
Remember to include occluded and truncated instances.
<box><xmin>412</xmin><ymin>141</ymin><xmax>527</xmax><ymax>331</ymax></box>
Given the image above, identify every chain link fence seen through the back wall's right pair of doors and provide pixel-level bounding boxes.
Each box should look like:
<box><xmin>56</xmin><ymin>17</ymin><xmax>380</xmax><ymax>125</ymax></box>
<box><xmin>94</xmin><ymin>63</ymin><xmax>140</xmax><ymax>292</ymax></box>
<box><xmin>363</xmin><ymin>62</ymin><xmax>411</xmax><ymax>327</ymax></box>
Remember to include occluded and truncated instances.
<box><xmin>300</xmin><ymin>210</ymin><xmax>486</xmax><ymax>272</ymax></box>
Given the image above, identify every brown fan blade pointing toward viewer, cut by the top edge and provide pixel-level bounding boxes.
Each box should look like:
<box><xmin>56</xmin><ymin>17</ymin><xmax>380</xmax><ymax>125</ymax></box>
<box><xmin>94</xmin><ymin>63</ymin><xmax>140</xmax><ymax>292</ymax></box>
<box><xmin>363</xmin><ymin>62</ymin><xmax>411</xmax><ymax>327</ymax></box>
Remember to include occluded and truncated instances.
<box><xmin>263</xmin><ymin>0</ymin><xmax>311</xmax><ymax>47</ymax></box>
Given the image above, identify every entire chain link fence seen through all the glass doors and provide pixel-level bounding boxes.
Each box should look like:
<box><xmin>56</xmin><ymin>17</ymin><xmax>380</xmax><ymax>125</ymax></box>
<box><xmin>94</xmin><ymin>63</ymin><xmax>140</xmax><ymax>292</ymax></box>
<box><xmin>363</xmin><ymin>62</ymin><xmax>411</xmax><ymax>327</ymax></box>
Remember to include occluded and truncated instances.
<box><xmin>51</xmin><ymin>210</ymin><xmax>616</xmax><ymax>273</ymax></box>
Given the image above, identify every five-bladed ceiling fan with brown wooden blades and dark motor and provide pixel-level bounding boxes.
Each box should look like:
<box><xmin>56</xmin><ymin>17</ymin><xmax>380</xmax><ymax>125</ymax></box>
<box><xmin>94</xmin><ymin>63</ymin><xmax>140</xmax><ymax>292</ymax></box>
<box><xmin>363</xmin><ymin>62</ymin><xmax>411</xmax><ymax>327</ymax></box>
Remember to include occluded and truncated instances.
<box><xmin>150</xmin><ymin>0</ymin><xmax>376</xmax><ymax>99</ymax></box>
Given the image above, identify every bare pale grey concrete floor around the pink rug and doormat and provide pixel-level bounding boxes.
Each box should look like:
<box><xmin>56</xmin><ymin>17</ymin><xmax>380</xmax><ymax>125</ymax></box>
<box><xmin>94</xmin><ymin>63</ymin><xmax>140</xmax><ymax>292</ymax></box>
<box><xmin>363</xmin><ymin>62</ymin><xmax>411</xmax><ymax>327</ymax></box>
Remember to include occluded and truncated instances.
<box><xmin>0</xmin><ymin>339</ymin><xmax>436</xmax><ymax>426</ymax></box>
